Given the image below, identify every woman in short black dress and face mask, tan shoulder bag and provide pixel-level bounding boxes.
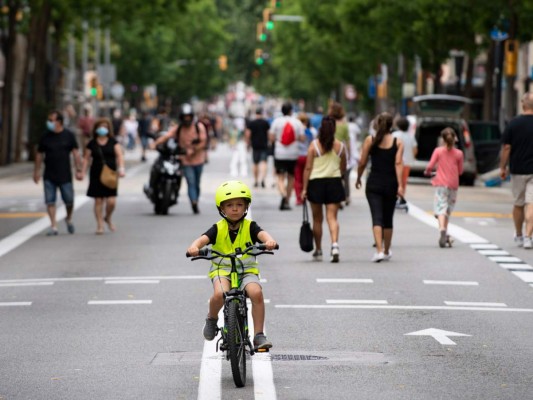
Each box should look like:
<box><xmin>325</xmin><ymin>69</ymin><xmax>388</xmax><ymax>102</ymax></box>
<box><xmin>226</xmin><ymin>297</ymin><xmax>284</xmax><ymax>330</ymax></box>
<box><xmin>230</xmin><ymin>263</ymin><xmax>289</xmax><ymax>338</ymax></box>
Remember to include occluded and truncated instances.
<box><xmin>82</xmin><ymin>118</ymin><xmax>125</xmax><ymax>235</ymax></box>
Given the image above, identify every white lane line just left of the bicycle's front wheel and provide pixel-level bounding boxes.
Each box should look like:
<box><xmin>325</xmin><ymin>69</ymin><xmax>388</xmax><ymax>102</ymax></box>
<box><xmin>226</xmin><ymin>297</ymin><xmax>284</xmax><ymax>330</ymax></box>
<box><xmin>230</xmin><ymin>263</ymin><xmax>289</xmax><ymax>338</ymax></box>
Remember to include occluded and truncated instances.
<box><xmin>198</xmin><ymin>309</ymin><xmax>224</xmax><ymax>400</ymax></box>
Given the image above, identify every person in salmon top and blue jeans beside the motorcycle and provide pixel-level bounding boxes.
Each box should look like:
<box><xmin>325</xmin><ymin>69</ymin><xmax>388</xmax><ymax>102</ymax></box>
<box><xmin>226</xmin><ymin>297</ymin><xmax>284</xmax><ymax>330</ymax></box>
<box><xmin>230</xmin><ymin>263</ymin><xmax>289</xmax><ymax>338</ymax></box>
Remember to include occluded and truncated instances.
<box><xmin>150</xmin><ymin>104</ymin><xmax>207</xmax><ymax>214</ymax></box>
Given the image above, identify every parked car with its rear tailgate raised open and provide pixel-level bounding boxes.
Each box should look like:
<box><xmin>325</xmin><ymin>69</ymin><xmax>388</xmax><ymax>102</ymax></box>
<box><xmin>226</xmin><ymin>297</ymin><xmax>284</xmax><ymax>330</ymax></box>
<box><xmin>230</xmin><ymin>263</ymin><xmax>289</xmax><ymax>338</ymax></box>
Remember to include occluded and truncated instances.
<box><xmin>410</xmin><ymin>94</ymin><xmax>477</xmax><ymax>186</ymax></box>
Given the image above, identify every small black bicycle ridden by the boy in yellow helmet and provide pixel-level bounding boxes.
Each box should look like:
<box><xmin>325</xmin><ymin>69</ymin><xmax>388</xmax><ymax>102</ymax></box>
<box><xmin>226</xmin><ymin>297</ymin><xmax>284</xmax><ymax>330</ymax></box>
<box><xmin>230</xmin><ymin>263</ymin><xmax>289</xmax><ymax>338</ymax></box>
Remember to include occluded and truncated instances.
<box><xmin>187</xmin><ymin>244</ymin><xmax>279</xmax><ymax>387</ymax></box>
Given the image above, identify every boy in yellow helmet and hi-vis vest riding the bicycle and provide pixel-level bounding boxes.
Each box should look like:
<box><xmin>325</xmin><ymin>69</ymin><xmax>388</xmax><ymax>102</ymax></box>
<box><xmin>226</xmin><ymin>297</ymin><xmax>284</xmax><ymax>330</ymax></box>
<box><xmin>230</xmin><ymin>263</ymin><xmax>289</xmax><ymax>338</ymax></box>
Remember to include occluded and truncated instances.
<box><xmin>187</xmin><ymin>181</ymin><xmax>276</xmax><ymax>349</ymax></box>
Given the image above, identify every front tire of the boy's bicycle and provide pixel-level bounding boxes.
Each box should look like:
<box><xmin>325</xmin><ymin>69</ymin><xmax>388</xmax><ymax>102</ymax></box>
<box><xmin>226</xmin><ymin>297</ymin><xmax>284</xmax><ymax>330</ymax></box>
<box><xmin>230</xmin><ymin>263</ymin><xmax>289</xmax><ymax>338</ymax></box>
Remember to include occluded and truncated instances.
<box><xmin>227</xmin><ymin>301</ymin><xmax>246</xmax><ymax>387</ymax></box>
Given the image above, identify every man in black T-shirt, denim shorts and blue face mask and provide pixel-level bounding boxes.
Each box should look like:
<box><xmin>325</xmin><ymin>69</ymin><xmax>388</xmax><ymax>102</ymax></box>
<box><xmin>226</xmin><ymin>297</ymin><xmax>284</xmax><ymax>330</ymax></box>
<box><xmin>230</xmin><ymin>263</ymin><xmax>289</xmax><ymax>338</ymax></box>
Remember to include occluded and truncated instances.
<box><xmin>33</xmin><ymin>111</ymin><xmax>83</xmax><ymax>236</ymax></box>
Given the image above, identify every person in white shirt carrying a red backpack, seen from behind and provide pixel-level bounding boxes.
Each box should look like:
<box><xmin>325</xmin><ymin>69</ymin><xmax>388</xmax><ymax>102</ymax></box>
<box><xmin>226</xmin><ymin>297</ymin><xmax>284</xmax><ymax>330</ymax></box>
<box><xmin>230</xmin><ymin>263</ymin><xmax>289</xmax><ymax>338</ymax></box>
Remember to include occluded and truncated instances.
<box><xmin>269</xmin><ymin>103</ymin><xmax>305</xmax><ymax>210</ymax></box>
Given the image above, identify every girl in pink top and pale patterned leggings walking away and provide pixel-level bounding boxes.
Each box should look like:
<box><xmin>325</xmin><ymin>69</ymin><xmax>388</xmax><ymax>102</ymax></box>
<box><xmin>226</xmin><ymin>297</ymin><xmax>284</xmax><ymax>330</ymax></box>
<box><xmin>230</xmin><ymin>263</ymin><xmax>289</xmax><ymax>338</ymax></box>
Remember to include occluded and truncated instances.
<box><xmin>424</xmin><ymin>128</ymin><xmax>463</xmax><ymax>247</ymax></box>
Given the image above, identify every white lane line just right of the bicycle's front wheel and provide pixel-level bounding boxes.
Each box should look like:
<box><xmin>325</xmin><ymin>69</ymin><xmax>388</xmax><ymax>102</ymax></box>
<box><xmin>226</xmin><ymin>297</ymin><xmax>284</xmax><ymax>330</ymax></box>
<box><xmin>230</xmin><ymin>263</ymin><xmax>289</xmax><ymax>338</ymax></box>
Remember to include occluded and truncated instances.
<box><xmin>248</xmin><ymin>296</ymin><xmax>277</xmax><ymax>400</ymax></box>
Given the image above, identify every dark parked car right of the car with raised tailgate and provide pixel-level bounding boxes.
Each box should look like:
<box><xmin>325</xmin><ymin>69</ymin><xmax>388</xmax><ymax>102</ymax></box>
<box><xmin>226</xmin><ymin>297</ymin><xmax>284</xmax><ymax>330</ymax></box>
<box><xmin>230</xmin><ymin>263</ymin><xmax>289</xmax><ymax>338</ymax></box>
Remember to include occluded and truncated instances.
<box><xmin>468</xmin><ymin>121</ymin><xmax>502</xmax><ymax>174</ymax></box>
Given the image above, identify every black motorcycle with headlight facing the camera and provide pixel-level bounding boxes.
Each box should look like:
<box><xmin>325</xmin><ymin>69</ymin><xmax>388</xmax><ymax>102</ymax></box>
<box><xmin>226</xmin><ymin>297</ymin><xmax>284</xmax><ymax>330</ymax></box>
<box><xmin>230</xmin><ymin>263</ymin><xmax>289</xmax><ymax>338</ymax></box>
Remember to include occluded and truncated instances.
<box><xmin>144</xmin><ymin>139</ymin><xmax>185</xmax><ymax>215</ymax></box>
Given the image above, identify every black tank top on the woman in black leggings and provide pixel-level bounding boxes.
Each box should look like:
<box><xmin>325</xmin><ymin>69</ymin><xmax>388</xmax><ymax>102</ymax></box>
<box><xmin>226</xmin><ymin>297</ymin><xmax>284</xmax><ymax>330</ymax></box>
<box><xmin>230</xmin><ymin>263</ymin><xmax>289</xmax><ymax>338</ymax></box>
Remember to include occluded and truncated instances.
<box><xmin>366</xmin><ymin>138</ymin><xmax>398</xmax><ymax>195</ymax></box>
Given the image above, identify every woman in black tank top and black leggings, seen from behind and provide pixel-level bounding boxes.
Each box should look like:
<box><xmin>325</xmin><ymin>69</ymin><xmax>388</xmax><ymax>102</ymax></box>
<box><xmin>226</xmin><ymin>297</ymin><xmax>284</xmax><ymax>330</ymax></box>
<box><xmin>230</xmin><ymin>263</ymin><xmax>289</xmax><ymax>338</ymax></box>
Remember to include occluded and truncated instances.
<box><xmin>355</xmin><ymin>112</ymin><xmax>403</xmax><ymax>262</ymax></box>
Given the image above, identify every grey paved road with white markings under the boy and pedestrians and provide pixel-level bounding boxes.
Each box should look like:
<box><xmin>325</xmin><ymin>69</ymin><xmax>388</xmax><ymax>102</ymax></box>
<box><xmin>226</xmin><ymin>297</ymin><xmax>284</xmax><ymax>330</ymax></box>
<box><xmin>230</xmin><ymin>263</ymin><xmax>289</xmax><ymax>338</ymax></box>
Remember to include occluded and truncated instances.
<box><xmin>0</xmin><ymin>146</ymin><xmax>533</xmax><ymax>400</ymax></box>
